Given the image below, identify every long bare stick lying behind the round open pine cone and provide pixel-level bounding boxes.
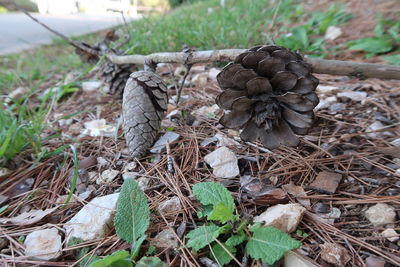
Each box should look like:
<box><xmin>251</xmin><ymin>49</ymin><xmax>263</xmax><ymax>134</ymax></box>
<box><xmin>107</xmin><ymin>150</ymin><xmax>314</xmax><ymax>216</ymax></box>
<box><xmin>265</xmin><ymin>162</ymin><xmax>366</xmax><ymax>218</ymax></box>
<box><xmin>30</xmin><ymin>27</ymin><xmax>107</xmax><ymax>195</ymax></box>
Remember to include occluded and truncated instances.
<box><xmin>107</xmin><ymin>49</ymin><xmax>400</xmax><ymax>80</ymax></box>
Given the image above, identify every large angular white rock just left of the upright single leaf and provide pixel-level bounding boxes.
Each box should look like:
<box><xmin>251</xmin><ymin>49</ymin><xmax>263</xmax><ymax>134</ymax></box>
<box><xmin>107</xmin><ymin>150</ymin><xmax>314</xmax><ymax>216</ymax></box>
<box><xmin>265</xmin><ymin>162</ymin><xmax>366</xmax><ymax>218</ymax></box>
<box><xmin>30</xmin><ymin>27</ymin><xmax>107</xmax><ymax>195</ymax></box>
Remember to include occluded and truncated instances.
<box><xmin>64</xmin><ymin>193</ymin><xmax>119</xmax><ymax>241</ymax></box>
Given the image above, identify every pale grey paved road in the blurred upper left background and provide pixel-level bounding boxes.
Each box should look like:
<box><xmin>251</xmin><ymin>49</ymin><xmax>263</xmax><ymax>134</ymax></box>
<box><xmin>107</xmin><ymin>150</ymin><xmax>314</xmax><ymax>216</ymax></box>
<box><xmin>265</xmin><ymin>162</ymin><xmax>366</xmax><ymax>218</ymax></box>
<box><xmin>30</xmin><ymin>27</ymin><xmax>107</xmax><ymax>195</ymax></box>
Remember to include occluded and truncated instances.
<box><xmin>0</xmin><ymin>13</ymin><xmax>133</xmax><ymax>55</ymax></box>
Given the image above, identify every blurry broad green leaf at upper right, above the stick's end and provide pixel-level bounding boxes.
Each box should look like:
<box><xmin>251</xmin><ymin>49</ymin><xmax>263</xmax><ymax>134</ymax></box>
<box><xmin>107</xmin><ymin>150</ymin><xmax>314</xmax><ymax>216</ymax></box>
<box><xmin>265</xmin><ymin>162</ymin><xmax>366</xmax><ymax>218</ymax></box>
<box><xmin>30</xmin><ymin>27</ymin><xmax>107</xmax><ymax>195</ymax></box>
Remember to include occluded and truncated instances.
<box><xmin>347</xmin><ymin>36</ymin><xmax>393</xmax><ymax>54</ymax></box>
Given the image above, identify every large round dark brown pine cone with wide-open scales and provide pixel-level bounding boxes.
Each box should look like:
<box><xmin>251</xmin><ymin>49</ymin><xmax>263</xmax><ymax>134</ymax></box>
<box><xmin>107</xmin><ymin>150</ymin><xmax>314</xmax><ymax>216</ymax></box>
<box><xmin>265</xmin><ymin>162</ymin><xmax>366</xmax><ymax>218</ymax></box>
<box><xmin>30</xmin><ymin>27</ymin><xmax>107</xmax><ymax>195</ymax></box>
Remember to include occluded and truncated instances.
<box><xmin>216</xmin><ymin>45</ymin><xmax>319</xmax><ymax>149</ymax></box>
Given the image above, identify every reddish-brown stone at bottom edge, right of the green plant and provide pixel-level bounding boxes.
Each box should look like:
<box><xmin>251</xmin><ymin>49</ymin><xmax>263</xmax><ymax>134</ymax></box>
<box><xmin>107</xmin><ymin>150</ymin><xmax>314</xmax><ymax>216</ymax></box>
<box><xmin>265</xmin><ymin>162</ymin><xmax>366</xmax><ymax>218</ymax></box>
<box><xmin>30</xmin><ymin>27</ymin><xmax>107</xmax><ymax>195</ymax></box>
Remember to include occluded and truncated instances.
<box><xmin>320</xmin><ymin>243</ymin><xmax>351</xmax><ymax>267</ymax></box>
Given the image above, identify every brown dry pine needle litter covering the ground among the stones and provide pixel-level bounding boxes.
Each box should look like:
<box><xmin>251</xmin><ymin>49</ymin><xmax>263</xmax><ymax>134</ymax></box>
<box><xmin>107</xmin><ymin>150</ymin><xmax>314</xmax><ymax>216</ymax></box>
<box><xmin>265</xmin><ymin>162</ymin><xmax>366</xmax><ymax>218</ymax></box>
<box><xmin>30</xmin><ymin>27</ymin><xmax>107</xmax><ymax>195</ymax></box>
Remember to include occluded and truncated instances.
<box><xmin>0</xmin><ymin>64</ymin><xmax>400</xmax><ymax>266</ymax></box>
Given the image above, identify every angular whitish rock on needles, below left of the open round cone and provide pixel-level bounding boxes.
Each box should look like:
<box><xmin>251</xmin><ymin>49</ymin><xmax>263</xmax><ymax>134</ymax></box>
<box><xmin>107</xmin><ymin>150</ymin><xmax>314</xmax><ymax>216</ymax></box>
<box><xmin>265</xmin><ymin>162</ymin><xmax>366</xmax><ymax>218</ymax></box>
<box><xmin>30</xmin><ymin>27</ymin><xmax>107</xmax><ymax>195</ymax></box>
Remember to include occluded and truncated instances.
<box><xmin>204</xmin><ymin>146</ymin><xmax>239</xmax><ymax>178</ymax></box>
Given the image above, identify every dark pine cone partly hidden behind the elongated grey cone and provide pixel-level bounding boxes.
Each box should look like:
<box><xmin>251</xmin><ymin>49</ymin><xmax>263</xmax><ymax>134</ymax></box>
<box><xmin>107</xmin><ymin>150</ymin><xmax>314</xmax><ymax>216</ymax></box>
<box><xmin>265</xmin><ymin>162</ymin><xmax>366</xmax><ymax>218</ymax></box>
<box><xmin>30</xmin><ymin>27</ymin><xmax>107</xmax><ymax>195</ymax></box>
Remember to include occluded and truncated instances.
<box><xmin>100</xmin><ymin>60</ymin><xmax>136</xmax><ymax>97</ymax></box>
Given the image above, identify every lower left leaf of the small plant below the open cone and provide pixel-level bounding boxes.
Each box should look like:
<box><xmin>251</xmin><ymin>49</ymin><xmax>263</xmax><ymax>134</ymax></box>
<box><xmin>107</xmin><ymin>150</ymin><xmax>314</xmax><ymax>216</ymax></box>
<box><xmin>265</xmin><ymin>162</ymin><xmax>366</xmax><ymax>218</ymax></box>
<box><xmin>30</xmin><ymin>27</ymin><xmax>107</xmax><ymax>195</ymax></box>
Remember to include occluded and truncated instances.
<box><xmin>186</xmin><ymin>224</ymin><xmax>223</xmax><ymax>251</ymax></box>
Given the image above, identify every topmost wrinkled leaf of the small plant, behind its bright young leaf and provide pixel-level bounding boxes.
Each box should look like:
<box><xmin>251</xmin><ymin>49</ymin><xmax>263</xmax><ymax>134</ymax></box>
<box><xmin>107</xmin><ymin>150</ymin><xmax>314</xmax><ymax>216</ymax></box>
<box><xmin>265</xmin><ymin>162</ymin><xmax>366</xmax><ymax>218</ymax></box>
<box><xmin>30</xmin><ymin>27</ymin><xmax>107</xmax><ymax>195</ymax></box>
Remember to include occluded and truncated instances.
<box><xmin>193</xmin><ymin>182</ymin><xmax>235</xmax><ymax>223</ymax></box>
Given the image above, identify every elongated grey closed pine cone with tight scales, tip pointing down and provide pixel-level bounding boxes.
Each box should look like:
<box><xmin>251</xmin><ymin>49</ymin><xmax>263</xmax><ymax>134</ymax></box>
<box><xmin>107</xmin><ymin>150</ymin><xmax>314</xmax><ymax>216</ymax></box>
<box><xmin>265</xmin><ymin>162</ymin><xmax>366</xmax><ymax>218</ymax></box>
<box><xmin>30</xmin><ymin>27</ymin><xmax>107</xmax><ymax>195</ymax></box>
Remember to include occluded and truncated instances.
<box><xmin>122</xmin><ymin>71</ymin><xmax>168</xmax><ymax>157</ymax></box>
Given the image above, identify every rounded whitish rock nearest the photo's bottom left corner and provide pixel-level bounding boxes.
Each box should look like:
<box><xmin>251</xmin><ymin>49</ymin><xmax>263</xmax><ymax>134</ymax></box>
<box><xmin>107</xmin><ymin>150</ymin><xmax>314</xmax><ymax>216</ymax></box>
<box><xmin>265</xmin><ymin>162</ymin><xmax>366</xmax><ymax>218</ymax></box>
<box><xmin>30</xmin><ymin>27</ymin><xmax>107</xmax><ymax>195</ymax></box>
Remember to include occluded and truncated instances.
<box><xmin>24</xmin><ymin>227</ymin><xmax>62</xmax><ymax>261</ymax></box>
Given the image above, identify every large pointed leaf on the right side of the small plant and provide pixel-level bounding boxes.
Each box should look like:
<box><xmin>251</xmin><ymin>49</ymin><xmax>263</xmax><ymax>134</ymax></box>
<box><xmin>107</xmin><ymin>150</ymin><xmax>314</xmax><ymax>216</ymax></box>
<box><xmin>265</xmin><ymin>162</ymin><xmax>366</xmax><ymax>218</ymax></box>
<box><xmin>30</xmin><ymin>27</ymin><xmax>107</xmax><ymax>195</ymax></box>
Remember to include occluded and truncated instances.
<box><xmin>246</xmin><ymin>227</ymin><xmax>301</xmax><ymax>264</ymax></box>
